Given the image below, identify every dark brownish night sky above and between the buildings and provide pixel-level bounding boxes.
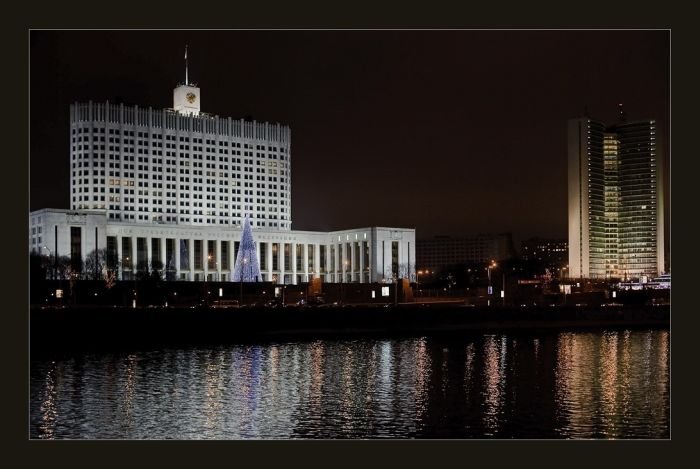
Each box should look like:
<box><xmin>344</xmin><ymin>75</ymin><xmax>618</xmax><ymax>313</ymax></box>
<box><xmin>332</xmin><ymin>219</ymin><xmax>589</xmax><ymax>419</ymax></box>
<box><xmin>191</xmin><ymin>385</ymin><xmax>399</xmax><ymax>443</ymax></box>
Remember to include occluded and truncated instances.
<box><xmin>30</xmin><ymin>30</ymin><xmax>670</xmax><ymax>240</ymax></box>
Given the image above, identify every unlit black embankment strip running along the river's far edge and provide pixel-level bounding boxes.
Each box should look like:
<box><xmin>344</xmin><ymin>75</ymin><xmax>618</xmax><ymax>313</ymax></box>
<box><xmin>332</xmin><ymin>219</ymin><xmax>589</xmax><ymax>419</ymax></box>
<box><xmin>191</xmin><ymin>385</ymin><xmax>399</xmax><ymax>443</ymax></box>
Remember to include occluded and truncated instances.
<box><xmin>30</xmin><ymin>304</ymin><xmax>670</xmax><ymax>350</ymax></box>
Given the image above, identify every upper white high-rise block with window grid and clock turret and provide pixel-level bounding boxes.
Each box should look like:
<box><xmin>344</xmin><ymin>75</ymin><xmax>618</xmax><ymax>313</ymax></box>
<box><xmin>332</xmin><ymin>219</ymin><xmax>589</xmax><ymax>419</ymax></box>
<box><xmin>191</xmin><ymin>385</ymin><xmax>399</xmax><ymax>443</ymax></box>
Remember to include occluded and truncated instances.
<box><xmin>70</xmin><ymin>85</ymin><xmax>292</xmax><ymax>230</ymax></box>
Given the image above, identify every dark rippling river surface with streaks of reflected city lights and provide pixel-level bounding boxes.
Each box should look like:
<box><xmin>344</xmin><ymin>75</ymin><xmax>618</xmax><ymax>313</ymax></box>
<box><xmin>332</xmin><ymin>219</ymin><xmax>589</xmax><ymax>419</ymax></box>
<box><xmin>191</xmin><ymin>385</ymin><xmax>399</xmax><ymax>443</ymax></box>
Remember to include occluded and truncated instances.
<box><xmin>30</xmin><ymin>330</ymin><xmax>670</xmax><ymax>439</ymax></box>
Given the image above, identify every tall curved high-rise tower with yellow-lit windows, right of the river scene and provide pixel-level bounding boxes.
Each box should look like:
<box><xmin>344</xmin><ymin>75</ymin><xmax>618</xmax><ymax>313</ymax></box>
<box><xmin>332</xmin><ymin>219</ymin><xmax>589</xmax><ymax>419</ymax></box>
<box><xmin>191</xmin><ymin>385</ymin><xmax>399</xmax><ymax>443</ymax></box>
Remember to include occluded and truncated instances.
<box><xmin>568</xmin><ymin>105</ymin><xmax>664</xmax><ymax>278</ymax></box>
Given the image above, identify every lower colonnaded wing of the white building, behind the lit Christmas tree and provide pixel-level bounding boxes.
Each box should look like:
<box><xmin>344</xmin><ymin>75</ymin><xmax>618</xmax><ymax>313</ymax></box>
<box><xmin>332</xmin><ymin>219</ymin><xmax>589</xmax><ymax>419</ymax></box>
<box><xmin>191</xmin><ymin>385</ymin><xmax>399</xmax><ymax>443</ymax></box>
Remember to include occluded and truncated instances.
<box><xmin>30</xmin><ymin>209</ymin><xmax>415</xmax><ymax>284</ymax></box>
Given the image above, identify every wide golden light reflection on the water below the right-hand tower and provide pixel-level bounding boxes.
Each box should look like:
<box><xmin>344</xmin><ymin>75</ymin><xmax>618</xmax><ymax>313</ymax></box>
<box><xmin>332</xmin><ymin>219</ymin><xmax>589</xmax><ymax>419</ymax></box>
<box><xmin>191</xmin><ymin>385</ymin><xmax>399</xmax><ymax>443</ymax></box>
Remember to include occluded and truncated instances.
<box><xmin>556</xmin><ymin>331</ymin><xmax>669</xmax><ymax>438</ymax></box>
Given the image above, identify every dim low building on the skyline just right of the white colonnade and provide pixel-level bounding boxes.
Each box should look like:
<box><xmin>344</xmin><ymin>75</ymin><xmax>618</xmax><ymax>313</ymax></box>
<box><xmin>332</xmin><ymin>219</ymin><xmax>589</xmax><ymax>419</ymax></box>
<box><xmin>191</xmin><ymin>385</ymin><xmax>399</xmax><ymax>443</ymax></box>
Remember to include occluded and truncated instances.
<box><xmin>416</xmin><ymin>233</ymin><xmax>514</xmax><ymax>270</ymax></box>
